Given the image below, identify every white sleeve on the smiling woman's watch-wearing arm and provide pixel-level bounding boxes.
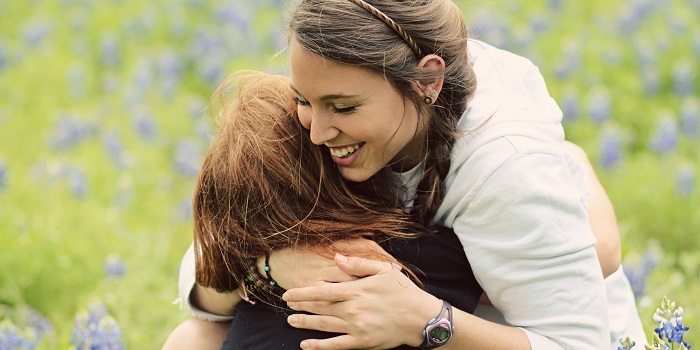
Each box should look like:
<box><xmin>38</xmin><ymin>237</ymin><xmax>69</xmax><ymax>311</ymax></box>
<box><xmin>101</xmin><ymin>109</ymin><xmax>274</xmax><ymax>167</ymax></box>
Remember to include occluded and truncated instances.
<box><xmin>438</xmin><ymin>137</ymin><xmax>610</xmax><ymax>350</ymax></box>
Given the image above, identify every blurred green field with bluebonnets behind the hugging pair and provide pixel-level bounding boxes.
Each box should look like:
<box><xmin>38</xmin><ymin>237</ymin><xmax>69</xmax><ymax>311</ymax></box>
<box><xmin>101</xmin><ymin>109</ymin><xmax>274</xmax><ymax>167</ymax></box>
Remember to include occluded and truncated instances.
<box><xmin>0</xmin><ymin>0</ymin><xmax>700</xmax><ymax>349</ymax></box>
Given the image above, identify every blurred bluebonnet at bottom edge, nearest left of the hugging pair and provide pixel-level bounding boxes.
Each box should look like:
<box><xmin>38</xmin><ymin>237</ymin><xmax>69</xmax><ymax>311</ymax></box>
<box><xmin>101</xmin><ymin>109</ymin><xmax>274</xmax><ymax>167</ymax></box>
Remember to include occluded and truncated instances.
<box><xmin>70</xmin><ymin>303</ymin><xmax>124</xmax><ymax>350</ymax></box>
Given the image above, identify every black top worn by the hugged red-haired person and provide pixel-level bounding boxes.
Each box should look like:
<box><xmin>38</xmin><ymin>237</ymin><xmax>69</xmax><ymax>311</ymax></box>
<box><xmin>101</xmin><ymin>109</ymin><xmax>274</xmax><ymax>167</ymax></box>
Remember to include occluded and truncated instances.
<box><xmin>222</xmin><ymin>229</ymin><xmax>482</xmax><ymax>350</ymax></box>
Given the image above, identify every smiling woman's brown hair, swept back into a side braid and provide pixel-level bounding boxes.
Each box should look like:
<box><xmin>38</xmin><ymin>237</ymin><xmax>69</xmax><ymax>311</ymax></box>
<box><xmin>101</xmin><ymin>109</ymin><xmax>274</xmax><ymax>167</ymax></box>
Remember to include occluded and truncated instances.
<box><xmin>287</xmin><ymin>0</ymin><xmax>476</xmax><ymax>225</ymax></box>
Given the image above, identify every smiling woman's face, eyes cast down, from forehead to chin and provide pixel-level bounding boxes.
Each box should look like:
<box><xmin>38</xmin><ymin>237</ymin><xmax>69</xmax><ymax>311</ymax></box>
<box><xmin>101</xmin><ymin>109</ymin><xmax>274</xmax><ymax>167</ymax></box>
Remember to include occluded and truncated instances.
<box><xmin>289</xmin><ymin>39</ymin><xmax>422</xmax><ymax>182</ymax></box>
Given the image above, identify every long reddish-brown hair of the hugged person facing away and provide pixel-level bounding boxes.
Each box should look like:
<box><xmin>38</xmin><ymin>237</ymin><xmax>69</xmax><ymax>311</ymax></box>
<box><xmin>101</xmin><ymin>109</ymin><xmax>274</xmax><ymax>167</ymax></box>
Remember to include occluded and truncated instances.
<box><xmin>193</xmin><ymin>71</ymin><xmax>422</xmax><ymax>291</ymax></box>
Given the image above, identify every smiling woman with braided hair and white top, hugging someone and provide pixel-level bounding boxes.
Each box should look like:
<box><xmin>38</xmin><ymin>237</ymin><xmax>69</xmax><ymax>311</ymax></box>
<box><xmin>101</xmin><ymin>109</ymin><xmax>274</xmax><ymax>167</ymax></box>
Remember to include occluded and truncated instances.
<box><xmin>165</xmin><ymin>0</ymin><xmax>645</xmax><ymax>349</ymax></box>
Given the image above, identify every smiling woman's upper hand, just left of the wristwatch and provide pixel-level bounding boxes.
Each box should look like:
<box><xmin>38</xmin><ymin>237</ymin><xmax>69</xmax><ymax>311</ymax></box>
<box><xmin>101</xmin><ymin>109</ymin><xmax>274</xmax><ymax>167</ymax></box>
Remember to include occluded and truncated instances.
<box><xmin>282</xmin><ymin>254</ymin><xmax>442</xmax><ymax>349</ymax></box>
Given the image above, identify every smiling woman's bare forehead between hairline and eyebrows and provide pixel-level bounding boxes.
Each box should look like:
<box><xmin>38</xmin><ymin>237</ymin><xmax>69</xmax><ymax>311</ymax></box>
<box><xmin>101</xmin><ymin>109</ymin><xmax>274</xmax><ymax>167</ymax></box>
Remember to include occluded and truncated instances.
<box><xmin>289</xmin><ymin>39</ymin><xmax>391</xmax><ymax>98</ymax></box>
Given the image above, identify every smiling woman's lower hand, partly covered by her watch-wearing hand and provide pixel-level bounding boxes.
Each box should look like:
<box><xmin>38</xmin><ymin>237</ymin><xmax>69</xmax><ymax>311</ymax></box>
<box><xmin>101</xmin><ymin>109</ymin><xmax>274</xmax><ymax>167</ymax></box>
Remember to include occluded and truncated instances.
<box><xmin>258</xmin><ymin>238</ymin><xmax>396</xmax><ymax>290</ymax></box>
